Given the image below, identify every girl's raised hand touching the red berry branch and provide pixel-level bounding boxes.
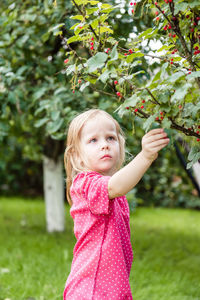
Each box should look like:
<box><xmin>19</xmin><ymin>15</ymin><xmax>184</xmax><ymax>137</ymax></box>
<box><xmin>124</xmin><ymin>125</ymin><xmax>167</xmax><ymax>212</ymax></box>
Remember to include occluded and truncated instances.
<box><xmin>141</xmin><ymin>128</ymin><xmax>170</xmax><ymax>160</ymax></box>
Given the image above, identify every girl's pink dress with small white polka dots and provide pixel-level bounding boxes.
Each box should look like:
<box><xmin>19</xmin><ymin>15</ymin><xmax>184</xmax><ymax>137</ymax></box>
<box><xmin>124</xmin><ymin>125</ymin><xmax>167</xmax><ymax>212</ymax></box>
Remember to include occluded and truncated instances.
<box><xmin>63</xmin><ymin>172</ymin><xmax>133</xmax><ymax>300</ymax></box>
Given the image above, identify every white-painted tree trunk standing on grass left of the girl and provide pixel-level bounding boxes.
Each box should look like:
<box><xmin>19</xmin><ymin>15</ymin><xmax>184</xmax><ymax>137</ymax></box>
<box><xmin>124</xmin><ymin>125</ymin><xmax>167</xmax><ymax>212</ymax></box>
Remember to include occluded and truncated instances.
<box><xmin>43</xmin><ymin>156</ymin><xmax>65</xmax><ymax>232</ymax></box>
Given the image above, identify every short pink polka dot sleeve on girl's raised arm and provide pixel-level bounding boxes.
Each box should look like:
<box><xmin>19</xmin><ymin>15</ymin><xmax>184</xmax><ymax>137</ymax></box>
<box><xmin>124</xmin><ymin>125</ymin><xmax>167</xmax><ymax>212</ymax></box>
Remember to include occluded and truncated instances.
<box><xmin>72</xmin><ymin>172</ymin><xmax>111</xmax><ymax>214</ymax></box>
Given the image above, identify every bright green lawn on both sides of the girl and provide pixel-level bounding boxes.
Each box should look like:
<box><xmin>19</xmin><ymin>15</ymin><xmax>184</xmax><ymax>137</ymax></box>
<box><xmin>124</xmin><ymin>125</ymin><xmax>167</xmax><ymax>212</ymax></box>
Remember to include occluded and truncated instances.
<box><xmin>0</xmin><ymin>197</ymin><xmax>200</xmax><ymax>300</ymax></box>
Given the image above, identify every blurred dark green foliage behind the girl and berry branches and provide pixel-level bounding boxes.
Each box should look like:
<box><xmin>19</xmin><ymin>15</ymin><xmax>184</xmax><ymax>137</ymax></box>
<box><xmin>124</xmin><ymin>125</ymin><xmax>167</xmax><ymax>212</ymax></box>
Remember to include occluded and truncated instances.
<box><xmin>0</xmin><ymin>0</ymin><xmax>200</xmax><ymax>209</ymax></box>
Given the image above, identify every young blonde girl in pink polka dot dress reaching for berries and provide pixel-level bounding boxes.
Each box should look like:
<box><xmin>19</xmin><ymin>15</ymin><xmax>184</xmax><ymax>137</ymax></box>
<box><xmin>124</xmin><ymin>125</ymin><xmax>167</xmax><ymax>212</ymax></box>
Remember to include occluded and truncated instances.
<box><xmin>63</xmin><ymin>109</ymin><xmax>169</xmax><ymax>300</ymax></box>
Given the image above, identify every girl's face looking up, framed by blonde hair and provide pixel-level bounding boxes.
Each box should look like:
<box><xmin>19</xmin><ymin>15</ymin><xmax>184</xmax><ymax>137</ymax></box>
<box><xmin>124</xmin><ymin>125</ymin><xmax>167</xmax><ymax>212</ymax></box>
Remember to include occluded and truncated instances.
<box><xmin>80</xmin><ymin>115</ymin><xmax>120</xmax><ymax>176</ymax></box>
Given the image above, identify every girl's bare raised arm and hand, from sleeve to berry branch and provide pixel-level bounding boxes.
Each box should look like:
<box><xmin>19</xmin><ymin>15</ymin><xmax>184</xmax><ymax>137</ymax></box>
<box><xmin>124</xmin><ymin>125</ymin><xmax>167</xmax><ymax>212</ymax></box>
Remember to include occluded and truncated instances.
<box><xmin>108</xmin><ymin>128</ymin><xmax>169</xmax><ymax>199</ymax></box>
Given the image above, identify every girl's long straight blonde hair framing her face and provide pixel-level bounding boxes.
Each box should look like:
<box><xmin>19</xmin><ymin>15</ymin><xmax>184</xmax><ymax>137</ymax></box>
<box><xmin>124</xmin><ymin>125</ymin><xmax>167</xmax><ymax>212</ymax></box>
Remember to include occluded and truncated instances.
<box><xmin>64</xmin><ymin>109</ymin><xmax>125</xmax><ymax>205</ymax></box>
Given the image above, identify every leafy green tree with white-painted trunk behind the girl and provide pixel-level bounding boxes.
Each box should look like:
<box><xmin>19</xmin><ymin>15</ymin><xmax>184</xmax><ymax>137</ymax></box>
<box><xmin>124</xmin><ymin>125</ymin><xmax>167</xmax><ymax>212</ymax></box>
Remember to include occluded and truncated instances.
<box><xmin>0</xmin><ymin>1</ymin><xmax>93</xmax><ymax>231</ymax></box>
